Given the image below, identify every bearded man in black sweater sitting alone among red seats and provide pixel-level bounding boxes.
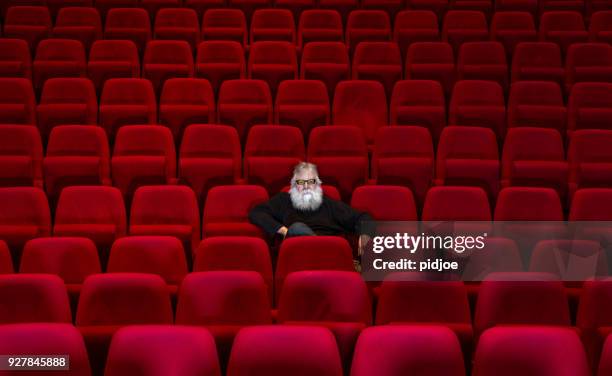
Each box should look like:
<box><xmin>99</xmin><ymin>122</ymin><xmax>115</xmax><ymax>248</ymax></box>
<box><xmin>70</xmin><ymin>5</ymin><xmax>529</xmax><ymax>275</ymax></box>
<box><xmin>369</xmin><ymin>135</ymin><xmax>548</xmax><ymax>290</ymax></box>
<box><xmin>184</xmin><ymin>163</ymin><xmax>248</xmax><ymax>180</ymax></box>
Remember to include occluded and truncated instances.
<box><xmin>249</xmin><ymin>162</ymin><xmax>372</xmax><ymax>254</ymax></box>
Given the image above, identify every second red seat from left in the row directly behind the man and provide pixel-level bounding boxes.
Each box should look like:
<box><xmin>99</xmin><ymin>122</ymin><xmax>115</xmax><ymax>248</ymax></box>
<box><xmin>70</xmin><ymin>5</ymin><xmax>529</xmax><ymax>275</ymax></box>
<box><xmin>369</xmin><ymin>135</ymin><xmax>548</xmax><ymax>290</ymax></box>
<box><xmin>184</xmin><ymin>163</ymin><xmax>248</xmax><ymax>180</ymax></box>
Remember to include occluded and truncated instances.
<box><xmin>43</xmin><ymin>125</ymin><xmax>111</xmax><ymax>198</ymax></box>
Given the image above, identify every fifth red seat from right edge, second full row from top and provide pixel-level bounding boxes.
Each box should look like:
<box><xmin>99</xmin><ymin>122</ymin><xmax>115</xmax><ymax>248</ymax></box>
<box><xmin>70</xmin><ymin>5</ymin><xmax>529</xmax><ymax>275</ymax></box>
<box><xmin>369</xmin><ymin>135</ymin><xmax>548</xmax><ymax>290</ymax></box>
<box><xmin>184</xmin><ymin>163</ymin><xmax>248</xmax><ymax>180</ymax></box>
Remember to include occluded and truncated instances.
<box><xmin>352</xmin><ymin>42</ymin><xmax>403</xmax><ymax>97</ymax></box>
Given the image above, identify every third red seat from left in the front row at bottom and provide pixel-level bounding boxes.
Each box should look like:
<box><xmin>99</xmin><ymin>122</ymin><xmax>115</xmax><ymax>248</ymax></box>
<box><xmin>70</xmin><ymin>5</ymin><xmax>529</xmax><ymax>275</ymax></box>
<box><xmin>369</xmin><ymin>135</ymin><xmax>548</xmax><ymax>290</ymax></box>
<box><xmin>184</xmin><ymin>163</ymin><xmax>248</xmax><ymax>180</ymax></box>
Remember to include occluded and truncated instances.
<box><xmin>227</xmin><ymin>326</ymin><xmax>343</xmax><ymax>376</ymax></box>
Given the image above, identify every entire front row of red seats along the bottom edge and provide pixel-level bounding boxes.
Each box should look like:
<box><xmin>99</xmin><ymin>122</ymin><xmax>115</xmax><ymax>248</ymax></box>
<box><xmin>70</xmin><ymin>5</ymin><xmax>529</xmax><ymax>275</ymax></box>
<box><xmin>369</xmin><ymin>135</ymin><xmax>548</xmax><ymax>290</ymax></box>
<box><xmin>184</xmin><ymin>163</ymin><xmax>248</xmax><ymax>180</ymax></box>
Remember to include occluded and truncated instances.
<box><xmin>0</xmin><ymin>324</ymin><xmax>612</xmax><ymax>376</ymax></box>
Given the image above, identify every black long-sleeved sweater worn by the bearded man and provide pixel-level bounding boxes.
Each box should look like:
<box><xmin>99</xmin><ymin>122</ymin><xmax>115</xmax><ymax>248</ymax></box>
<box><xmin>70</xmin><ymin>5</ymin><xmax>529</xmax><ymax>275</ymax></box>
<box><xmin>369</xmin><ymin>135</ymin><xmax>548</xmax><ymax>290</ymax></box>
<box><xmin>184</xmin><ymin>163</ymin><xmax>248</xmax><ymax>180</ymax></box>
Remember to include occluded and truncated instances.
<box><xmin>249</xmin><ymin>192</ymin><xmax>372</xmax><ymax>235</ymax></box>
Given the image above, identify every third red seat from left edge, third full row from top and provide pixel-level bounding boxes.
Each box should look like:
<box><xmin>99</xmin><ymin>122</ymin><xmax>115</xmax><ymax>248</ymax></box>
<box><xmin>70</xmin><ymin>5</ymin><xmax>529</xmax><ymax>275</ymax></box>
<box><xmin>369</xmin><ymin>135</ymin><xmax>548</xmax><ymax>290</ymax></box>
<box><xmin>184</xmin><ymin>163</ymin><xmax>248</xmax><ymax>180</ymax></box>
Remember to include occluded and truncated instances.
<box><xmin>99</xmin><ymin>78</ymin><xmax>157</xmax><ymax>139</ymax></box>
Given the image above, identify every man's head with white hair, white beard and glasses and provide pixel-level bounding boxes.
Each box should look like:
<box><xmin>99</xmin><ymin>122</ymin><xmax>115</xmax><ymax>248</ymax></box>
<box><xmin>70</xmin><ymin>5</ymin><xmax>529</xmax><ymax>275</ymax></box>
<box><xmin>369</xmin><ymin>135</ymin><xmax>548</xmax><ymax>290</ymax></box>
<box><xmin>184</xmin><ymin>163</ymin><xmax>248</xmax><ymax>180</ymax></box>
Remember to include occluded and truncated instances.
<box><xmin>289</xmin><ymin>162</ymin><xmax>323</xmax><ymax>210</ymax></box>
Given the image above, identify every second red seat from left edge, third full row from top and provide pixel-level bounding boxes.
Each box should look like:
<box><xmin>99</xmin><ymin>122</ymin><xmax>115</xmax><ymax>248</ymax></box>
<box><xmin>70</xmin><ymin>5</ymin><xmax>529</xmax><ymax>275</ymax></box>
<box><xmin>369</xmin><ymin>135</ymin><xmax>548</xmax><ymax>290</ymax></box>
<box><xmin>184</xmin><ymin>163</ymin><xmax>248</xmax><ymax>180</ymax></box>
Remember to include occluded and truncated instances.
<box><xmin>36</xmin><ymin>78</ymin><xmax>98</xmax><ymax>139</ymax></box>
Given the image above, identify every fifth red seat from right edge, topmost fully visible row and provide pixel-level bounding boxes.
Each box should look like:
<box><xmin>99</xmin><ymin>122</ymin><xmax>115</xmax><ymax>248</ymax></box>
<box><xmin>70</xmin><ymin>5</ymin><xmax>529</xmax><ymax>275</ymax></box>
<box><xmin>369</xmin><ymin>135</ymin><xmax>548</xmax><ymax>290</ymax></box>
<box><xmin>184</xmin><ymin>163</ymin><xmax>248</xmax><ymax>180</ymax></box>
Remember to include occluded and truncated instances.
<box><xmin>393</xmin><ymin>10</ymin><xmax>440</xmax><ymax>57</ymax></box>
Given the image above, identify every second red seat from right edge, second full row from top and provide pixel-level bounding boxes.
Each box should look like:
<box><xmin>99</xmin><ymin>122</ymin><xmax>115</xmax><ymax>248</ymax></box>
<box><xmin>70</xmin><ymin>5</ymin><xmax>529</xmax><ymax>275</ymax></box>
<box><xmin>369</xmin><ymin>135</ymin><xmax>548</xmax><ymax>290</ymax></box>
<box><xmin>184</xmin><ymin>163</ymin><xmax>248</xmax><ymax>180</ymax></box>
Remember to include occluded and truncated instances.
<box><xmin>511</xmin><ymin>42</ymin><xmax>564</xmax><ymax>84</ymax></box>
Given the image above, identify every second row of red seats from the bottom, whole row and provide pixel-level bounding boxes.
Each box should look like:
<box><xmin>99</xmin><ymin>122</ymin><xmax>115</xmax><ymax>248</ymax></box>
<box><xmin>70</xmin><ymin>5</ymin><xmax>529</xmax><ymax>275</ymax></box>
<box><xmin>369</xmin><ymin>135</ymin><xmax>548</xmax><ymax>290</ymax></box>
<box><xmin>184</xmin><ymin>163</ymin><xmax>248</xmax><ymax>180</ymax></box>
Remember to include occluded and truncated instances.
<box><xmin>0</xmin><ymin>271</ymin><xmax>611</xmax><ymax>374</ymax></box>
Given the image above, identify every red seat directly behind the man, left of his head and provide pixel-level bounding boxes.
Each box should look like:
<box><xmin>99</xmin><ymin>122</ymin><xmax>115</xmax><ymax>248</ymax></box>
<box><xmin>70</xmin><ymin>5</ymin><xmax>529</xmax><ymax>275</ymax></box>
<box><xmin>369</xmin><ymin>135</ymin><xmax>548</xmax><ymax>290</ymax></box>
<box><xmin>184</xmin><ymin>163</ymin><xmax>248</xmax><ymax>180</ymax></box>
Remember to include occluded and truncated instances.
<box><xmin>244</xmin><ymin>125</ymin><xmax>306</xmax><ymax>194</ymax></box>
